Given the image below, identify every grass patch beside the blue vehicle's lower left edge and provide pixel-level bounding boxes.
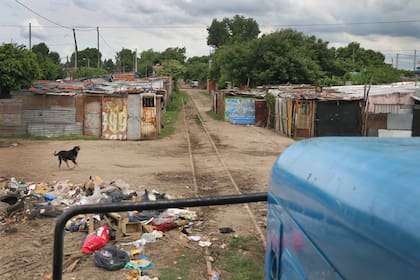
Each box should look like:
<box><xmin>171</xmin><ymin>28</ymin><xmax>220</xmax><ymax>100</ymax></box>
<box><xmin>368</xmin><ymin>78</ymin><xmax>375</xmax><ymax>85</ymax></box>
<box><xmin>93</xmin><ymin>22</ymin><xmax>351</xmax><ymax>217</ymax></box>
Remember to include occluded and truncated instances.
<box><xmin>221</xmin><ymin>236</ymin><xmax>264</xmax><ymax>280</ymax></box>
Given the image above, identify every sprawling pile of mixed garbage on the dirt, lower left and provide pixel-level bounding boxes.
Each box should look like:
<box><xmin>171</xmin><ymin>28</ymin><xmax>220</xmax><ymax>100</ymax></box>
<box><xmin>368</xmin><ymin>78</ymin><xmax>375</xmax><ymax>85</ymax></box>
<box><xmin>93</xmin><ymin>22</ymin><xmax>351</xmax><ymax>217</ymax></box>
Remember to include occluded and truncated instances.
<box><xmin>0</xmin><ymin>176</ymin><xmax>226</xmax><ymax>280</ymax></box>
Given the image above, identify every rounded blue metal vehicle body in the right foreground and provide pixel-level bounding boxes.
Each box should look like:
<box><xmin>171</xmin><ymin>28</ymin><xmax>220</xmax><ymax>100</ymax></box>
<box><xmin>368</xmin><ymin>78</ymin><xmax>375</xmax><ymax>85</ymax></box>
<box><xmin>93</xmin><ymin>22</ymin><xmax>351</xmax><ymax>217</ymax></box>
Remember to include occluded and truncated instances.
<box><xmin>265</xmin><ymin>137</ymin><xmax>420</xmax><ymax>279</ymax></box>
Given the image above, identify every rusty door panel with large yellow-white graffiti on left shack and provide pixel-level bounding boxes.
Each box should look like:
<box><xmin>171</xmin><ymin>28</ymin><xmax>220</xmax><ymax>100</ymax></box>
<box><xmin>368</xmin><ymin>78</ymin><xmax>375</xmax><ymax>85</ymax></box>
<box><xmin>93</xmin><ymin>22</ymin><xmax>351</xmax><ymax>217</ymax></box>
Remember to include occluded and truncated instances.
<box><xmin>102</xmin><ymin>98</ymin><xmax>128</xmax><ymax>140</ymax></box>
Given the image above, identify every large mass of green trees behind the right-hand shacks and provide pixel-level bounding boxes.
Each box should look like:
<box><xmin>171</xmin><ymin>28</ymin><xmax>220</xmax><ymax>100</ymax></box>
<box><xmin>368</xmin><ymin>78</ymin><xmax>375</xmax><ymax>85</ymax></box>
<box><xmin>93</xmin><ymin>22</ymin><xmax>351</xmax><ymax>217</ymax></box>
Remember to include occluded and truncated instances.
<box><xmin>207</xmin><ymin>15</ymin><xmax>409</xmax><ymax>88</ymax></box>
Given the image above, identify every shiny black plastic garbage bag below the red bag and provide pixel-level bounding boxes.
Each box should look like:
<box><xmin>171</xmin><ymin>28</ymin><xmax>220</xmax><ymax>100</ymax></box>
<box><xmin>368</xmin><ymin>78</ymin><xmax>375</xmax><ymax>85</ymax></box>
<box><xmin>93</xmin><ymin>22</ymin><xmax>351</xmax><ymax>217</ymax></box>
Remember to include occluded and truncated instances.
<box><xmin>93</xmin><ymin>245</ymin><xmax>129</xmax><ymax>271</ymax></box>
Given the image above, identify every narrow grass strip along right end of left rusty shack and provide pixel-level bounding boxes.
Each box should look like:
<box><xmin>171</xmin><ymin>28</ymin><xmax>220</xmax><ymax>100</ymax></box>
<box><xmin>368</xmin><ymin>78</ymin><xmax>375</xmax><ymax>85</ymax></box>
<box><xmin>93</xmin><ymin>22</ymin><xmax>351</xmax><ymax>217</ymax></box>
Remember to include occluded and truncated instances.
<box><xmin>159</xmin><ymin>90</ymin><xmax>190</xmax><ymax>138</ymax></box>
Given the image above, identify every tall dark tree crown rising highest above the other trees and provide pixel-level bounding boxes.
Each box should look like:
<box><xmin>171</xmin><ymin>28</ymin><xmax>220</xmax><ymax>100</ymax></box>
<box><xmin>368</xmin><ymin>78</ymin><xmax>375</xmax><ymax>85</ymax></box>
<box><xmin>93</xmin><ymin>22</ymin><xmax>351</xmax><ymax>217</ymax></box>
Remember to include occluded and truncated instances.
<box><xmin>207</xmin><ymin>15</ymin><xmax>260</xmax><ymax>48</ymax></box>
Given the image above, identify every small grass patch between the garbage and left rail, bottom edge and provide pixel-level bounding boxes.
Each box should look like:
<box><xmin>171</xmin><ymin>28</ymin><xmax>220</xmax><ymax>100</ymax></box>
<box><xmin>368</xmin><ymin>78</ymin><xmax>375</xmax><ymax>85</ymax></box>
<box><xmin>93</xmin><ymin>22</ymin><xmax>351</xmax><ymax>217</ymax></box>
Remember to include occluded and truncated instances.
<box><xmin>159</xmin><ymin>250</ymin><xmax>202</xmax><ymax>280</ymax></box>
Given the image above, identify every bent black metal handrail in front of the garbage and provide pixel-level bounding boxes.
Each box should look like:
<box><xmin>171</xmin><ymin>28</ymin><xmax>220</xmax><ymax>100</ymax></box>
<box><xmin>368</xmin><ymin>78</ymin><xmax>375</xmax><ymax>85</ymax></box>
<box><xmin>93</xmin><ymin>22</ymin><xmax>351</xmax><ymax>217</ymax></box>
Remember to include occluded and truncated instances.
<box><xmin>53</xmin><ymin>192</ymin><xmax>267</xmax><ymax>280</ymax></box>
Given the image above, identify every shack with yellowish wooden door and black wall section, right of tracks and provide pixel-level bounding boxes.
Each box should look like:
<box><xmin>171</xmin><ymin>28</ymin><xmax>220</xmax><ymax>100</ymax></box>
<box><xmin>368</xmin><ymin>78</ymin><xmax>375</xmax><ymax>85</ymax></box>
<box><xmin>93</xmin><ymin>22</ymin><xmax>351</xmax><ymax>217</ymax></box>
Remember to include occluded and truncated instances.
<box><xmin>268</xmin><ymin>85</ymin><xmax>362</xmax><ymax>138</ymax></box>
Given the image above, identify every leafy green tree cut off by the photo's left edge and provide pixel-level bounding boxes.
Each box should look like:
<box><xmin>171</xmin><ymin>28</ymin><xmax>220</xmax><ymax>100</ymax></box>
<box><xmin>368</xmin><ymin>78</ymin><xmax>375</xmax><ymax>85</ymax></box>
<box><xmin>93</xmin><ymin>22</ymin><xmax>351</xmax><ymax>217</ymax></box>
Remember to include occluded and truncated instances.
<box><xmin>0</xmin><ymin>44</ymin><xmax>41</xmax><ymax>98</ymax></box>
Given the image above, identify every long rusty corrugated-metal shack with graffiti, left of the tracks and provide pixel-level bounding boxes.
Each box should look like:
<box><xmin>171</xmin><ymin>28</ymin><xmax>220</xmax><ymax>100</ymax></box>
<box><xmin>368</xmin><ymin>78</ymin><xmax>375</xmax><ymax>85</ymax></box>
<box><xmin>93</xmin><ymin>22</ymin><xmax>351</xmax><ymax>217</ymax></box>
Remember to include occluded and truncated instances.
<box><xmin>0</xmin><ymin>76</ymin><xmax>171</xmax><ymax>140</ymax></box>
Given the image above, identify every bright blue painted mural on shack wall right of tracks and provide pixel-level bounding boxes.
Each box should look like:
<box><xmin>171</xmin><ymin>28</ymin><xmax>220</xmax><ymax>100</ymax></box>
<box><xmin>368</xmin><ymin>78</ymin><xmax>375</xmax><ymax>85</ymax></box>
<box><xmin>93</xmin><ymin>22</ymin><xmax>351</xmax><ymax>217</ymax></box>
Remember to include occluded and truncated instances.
<box><xmin>225</xmin><ymin>98</ymin><xmax>255</xmax><ymax>124</ymax></box>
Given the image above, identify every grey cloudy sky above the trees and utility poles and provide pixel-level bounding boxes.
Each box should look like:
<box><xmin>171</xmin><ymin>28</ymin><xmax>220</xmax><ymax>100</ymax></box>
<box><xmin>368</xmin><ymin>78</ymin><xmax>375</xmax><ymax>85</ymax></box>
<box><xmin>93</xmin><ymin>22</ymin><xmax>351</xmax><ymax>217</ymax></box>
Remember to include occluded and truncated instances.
<box><xmin>0</xmin><ymin>0</ymin><xmax>420</xmax><ymax>68</ymax></box>
